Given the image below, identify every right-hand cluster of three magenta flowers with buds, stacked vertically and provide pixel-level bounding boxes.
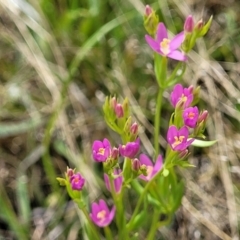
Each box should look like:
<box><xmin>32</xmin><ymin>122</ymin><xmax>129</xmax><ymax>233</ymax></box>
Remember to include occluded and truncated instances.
<box><xmin>167</xmin><ymin>84</ymin><xmax>208</xmax><ymax>158</ymax></box>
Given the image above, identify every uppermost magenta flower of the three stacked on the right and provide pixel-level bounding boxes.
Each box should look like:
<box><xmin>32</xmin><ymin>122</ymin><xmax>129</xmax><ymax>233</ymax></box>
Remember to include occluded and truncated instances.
<box><xmin>171</xmin><ymin>84</ymin><xmax>193</xmax><ymax>108</ymax></box>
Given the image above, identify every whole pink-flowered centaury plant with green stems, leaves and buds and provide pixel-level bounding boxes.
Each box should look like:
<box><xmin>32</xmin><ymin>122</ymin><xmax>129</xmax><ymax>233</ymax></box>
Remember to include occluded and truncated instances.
<box><xmin>57</xmin><ymin>6</ymin><xmax>214</xmax><ymax>240</ymax></box>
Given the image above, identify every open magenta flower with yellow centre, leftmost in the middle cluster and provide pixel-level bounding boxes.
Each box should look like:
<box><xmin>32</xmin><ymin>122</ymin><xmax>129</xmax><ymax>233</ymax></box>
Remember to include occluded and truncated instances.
<box><xmin>92</xmin><ymin>138</ymin><xmax>111</xmax><ymax>162</ymax></box>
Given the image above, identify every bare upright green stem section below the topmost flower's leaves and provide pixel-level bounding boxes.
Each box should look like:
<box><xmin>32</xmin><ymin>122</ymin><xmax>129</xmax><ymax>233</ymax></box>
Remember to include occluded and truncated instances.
<box><xmin>154</xmin><ymin>88</ymin><xmax>164</xmax><ymax>159</ymax></box>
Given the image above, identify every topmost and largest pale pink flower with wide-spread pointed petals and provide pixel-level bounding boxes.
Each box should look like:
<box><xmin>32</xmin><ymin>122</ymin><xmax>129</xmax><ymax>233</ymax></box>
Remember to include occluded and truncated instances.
<box><xmin>145</xmin><ymin>23</ymin><xmax>187</xmax><ymax>61</ymax></box>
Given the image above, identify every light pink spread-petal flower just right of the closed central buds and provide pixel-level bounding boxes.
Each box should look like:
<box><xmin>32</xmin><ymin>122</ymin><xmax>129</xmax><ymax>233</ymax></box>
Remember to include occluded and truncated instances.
<box><xmin>139</xmin><ymin>154</ymin><xmax>163</xmax><ymax>181</ymax></box>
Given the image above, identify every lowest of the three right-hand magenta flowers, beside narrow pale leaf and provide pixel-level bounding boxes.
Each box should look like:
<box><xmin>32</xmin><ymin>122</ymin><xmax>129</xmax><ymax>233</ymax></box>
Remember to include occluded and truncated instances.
<box><xmin>167</xmin><ymin>125</ymin><xmax>194</xmax><ymax>151</ymax></box>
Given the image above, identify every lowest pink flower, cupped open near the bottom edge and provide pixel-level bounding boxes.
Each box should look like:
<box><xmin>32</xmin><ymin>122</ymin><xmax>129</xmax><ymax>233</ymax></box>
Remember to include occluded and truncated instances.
<box><xmin>90</xmin><ymin>199</ymin><xmax>116</xmax><ymax>227</ymax></box>
